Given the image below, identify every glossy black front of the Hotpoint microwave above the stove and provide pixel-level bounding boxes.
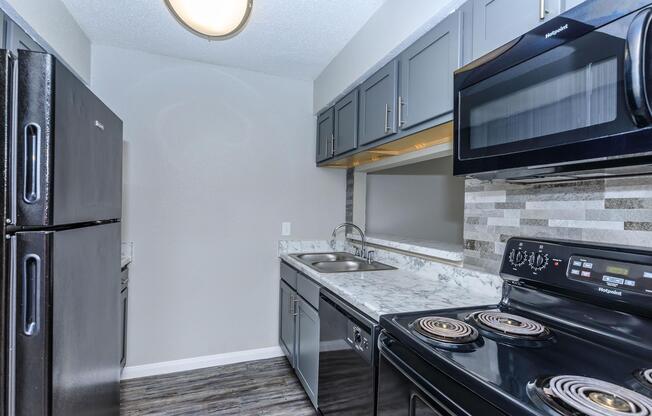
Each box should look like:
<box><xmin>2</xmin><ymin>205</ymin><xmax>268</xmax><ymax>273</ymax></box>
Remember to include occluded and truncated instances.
<box><xmin>455</xmin><ymin>8</ymin><xmax>652</xmax><ymax>175</ymax></box>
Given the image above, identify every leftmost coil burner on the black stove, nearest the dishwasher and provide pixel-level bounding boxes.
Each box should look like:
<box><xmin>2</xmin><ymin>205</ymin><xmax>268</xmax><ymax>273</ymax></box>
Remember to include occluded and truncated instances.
<box><xmin>411</xmin><ymin>316</ymin><xmax>479</xmax><ymax>349</ymax></box>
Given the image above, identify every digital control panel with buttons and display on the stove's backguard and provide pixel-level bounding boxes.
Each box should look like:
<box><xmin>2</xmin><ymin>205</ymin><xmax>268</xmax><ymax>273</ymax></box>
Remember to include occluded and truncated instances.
<box><xmin>566</xmin><ymin>256</ymin><xmax>652</xmax><ymax>295</ymax></box>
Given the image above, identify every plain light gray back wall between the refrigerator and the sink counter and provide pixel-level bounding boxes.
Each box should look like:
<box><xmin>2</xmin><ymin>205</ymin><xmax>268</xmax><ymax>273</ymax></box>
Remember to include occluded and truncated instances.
<box><xmin>92</xmin><ymin>46</ymin><xmax>345</xmax><ymax>366</ymax></box>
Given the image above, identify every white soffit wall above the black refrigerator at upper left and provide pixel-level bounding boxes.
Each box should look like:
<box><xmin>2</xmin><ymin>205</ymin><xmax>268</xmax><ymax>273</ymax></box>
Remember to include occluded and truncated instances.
<box><xmin>0</xmin><ymin>0</ymin><xmax>91</xmax><ymax>83</ymax></box>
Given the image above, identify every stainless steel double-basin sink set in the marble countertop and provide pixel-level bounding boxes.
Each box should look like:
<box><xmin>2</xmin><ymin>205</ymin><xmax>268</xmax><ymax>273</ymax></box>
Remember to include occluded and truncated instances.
<box><xmin>290</xmin><ymin>253</ymin><xmax>396</xmax><ymax>273</ymax></box>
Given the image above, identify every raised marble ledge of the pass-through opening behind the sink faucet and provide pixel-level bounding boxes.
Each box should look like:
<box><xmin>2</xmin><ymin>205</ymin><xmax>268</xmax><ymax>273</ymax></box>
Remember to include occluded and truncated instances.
<box><xmin>346</xmin><ymin>234</ymin><xmax>464</xmax><ymax>263</ymax></box>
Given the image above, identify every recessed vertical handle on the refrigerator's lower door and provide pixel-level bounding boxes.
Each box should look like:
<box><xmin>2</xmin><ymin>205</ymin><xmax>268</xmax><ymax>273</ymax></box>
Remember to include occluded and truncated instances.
<box><xmin>21</xmin><ymin>254</ymin><xmax>41</xmax><ymax>336</ymax></box>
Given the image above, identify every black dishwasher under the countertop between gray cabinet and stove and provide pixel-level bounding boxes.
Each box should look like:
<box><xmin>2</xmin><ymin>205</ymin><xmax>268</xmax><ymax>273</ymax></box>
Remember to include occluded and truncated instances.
<box><xmin>317</xmin><ymin>288</ymin><xmax>379</xmax><ymax>416</ymax></box>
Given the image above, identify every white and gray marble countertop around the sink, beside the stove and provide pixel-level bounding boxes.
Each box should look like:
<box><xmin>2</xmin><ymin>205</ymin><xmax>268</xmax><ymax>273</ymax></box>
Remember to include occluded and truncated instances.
<box><xmin>279</xmin><ymin>242</ymin><xmax>502</xmax><ymax>321</ymax></box>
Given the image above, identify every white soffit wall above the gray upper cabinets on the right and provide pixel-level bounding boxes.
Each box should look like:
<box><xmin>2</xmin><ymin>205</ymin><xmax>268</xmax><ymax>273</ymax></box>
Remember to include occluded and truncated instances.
<box><xmin>313</xmin><ymin>0</ymin><xmax>464</xmax><ymax>113</ymax></box>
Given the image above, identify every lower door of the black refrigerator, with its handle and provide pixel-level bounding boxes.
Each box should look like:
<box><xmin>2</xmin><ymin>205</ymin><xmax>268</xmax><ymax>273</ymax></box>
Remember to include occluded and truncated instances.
<box><xmin>13</xmin><ymin>223</ymin><xmax>120</xmax><ymax>416</ymax></box>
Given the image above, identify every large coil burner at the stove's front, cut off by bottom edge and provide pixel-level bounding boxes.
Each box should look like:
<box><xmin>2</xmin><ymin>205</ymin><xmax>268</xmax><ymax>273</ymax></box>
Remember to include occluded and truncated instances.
<box><xmin>528</xmin><ymin>376</ymin><xmax>652</xmax><ymax>416</ymax></box>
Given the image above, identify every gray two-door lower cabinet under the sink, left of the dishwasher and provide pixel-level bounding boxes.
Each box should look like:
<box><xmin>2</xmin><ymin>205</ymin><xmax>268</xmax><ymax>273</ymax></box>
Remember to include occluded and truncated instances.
<box><xmin>279</xmin><ymin>263</ymin><xmax>319</xmax><ymax>408</ymax></box>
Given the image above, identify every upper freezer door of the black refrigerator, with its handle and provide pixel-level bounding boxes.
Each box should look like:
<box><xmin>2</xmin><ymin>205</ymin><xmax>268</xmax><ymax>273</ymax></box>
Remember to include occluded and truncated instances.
<box><xmin>12</xmin><ymin>50</ymin><xmax>122</xmax><ymax>227</ymax></box>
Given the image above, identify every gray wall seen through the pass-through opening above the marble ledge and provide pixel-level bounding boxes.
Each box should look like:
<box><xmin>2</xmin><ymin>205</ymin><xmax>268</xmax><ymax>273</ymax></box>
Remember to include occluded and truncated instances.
<box><xmin>366</xmin><ymin>157</ymin><xmax>464</xmax><ymax>244</ymax></box>
